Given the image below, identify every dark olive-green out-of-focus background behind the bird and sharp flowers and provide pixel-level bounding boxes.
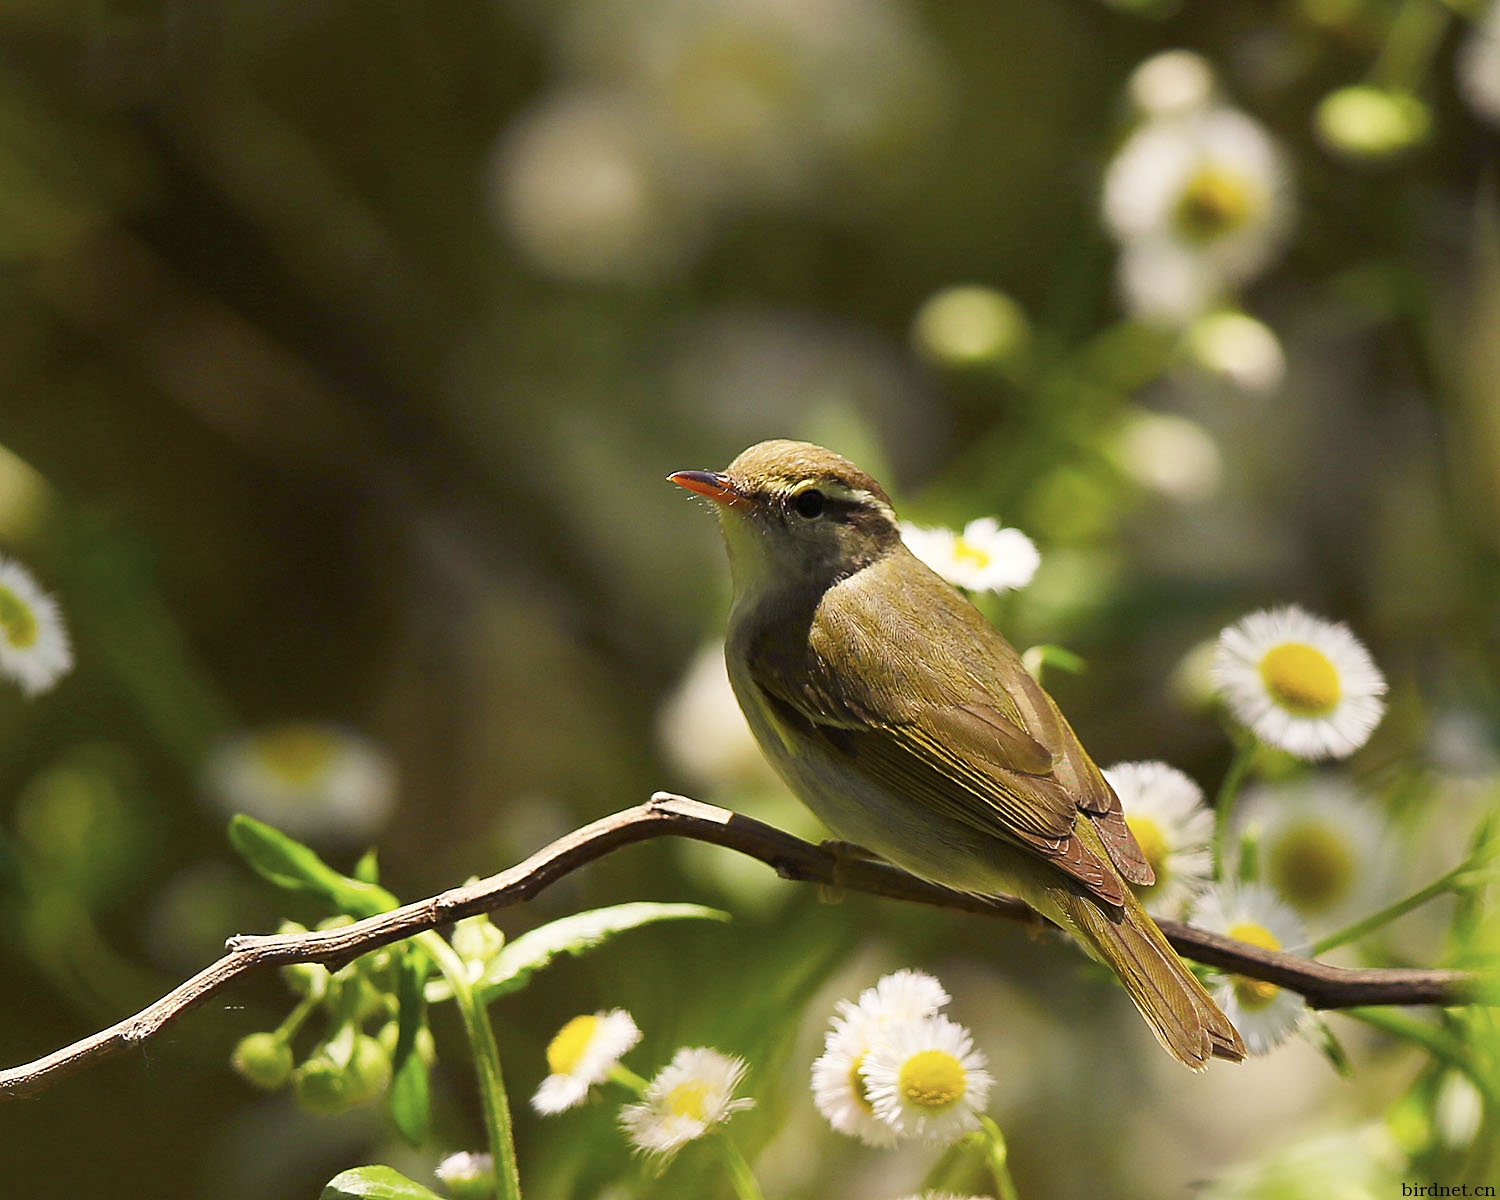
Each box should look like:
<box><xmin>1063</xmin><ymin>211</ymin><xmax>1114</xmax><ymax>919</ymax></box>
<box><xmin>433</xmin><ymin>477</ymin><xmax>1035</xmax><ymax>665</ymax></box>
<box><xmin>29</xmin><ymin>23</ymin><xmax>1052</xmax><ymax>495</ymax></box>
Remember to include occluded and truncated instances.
<box><xmin>0</xmin><ymin>0</ymin><xmax>1500</xmax><ymax>1200</ymax></box>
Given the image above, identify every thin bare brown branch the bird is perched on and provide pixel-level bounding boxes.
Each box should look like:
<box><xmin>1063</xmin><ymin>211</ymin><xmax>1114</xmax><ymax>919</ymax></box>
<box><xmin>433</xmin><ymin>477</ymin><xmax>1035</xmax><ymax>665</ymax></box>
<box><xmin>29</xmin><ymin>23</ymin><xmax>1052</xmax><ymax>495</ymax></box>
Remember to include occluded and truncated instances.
<box><xmin>0</xmin><ymin>792</ymin><xmax>1479</xmax><ymax>1098</ymax></box>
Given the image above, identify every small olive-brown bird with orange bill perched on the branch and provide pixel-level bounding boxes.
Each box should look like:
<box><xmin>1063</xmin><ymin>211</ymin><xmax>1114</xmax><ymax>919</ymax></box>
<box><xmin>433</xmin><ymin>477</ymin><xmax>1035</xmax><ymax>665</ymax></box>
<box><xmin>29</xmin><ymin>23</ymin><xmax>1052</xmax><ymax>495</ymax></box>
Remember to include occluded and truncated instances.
<box><xmin>669</xmin><ymin>441</ymin><xmax>1245</xmax><ymax>1070</ymax></box>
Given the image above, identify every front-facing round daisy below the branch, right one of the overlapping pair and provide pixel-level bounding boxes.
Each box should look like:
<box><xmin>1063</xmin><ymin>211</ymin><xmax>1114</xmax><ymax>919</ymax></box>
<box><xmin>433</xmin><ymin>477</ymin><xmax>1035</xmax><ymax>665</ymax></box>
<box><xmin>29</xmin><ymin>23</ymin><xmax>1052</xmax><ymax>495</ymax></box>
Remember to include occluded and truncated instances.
<box><xmin>860</xmin><ymin>1017</ymin><xmax>995</xmax><ymax>1142</ymax></box>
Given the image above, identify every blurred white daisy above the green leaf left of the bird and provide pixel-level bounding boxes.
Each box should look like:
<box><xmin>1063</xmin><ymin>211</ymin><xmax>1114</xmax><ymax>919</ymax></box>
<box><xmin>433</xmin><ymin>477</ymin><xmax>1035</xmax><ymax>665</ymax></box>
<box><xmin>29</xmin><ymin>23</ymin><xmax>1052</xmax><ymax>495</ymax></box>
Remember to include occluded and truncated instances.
<box><xmin>206</xmin><ymin>722</ymin><xmax>396</xmax><ymax>842</ymax></box>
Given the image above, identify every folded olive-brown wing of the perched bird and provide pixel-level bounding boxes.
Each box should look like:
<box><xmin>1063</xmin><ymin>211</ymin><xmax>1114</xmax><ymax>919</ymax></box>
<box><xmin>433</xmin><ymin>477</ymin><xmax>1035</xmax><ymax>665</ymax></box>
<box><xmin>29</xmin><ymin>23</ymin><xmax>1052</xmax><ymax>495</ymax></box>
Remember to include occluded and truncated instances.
<box><xmin>749</xmin><ymin>560</ymin><xmax>1149</xmax><ymax>905</ymax></box>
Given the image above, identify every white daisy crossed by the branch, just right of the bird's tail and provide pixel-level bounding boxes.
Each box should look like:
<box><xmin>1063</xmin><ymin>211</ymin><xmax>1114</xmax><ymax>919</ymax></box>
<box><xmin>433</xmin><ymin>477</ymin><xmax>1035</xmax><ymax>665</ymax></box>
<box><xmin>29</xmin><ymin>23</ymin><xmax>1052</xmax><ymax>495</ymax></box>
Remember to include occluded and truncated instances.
<box><xmin>1191</xmin><ymin>884</ymin><xmax>1308</xmax><ymax>1055</ymax></box>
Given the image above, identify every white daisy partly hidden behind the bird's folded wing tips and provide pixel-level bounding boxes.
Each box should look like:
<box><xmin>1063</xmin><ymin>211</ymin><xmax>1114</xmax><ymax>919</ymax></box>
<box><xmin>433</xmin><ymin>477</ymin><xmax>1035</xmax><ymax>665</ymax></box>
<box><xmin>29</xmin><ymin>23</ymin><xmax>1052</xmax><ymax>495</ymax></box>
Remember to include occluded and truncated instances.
<box><xmin>1104</xmin><ymin>762</ymin><xmax>1214</xmax><ymax>918</ymax></box>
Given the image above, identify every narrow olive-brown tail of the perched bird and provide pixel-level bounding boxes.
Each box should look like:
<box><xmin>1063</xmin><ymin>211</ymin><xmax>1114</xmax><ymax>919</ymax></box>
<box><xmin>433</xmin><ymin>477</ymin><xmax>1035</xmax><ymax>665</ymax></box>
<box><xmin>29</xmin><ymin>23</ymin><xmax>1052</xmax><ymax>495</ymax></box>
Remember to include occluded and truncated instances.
<box><xmin>1049</xmin><ymin>888</ymin><xmax>1245</xmax><ymax>1071</ymax></box>
